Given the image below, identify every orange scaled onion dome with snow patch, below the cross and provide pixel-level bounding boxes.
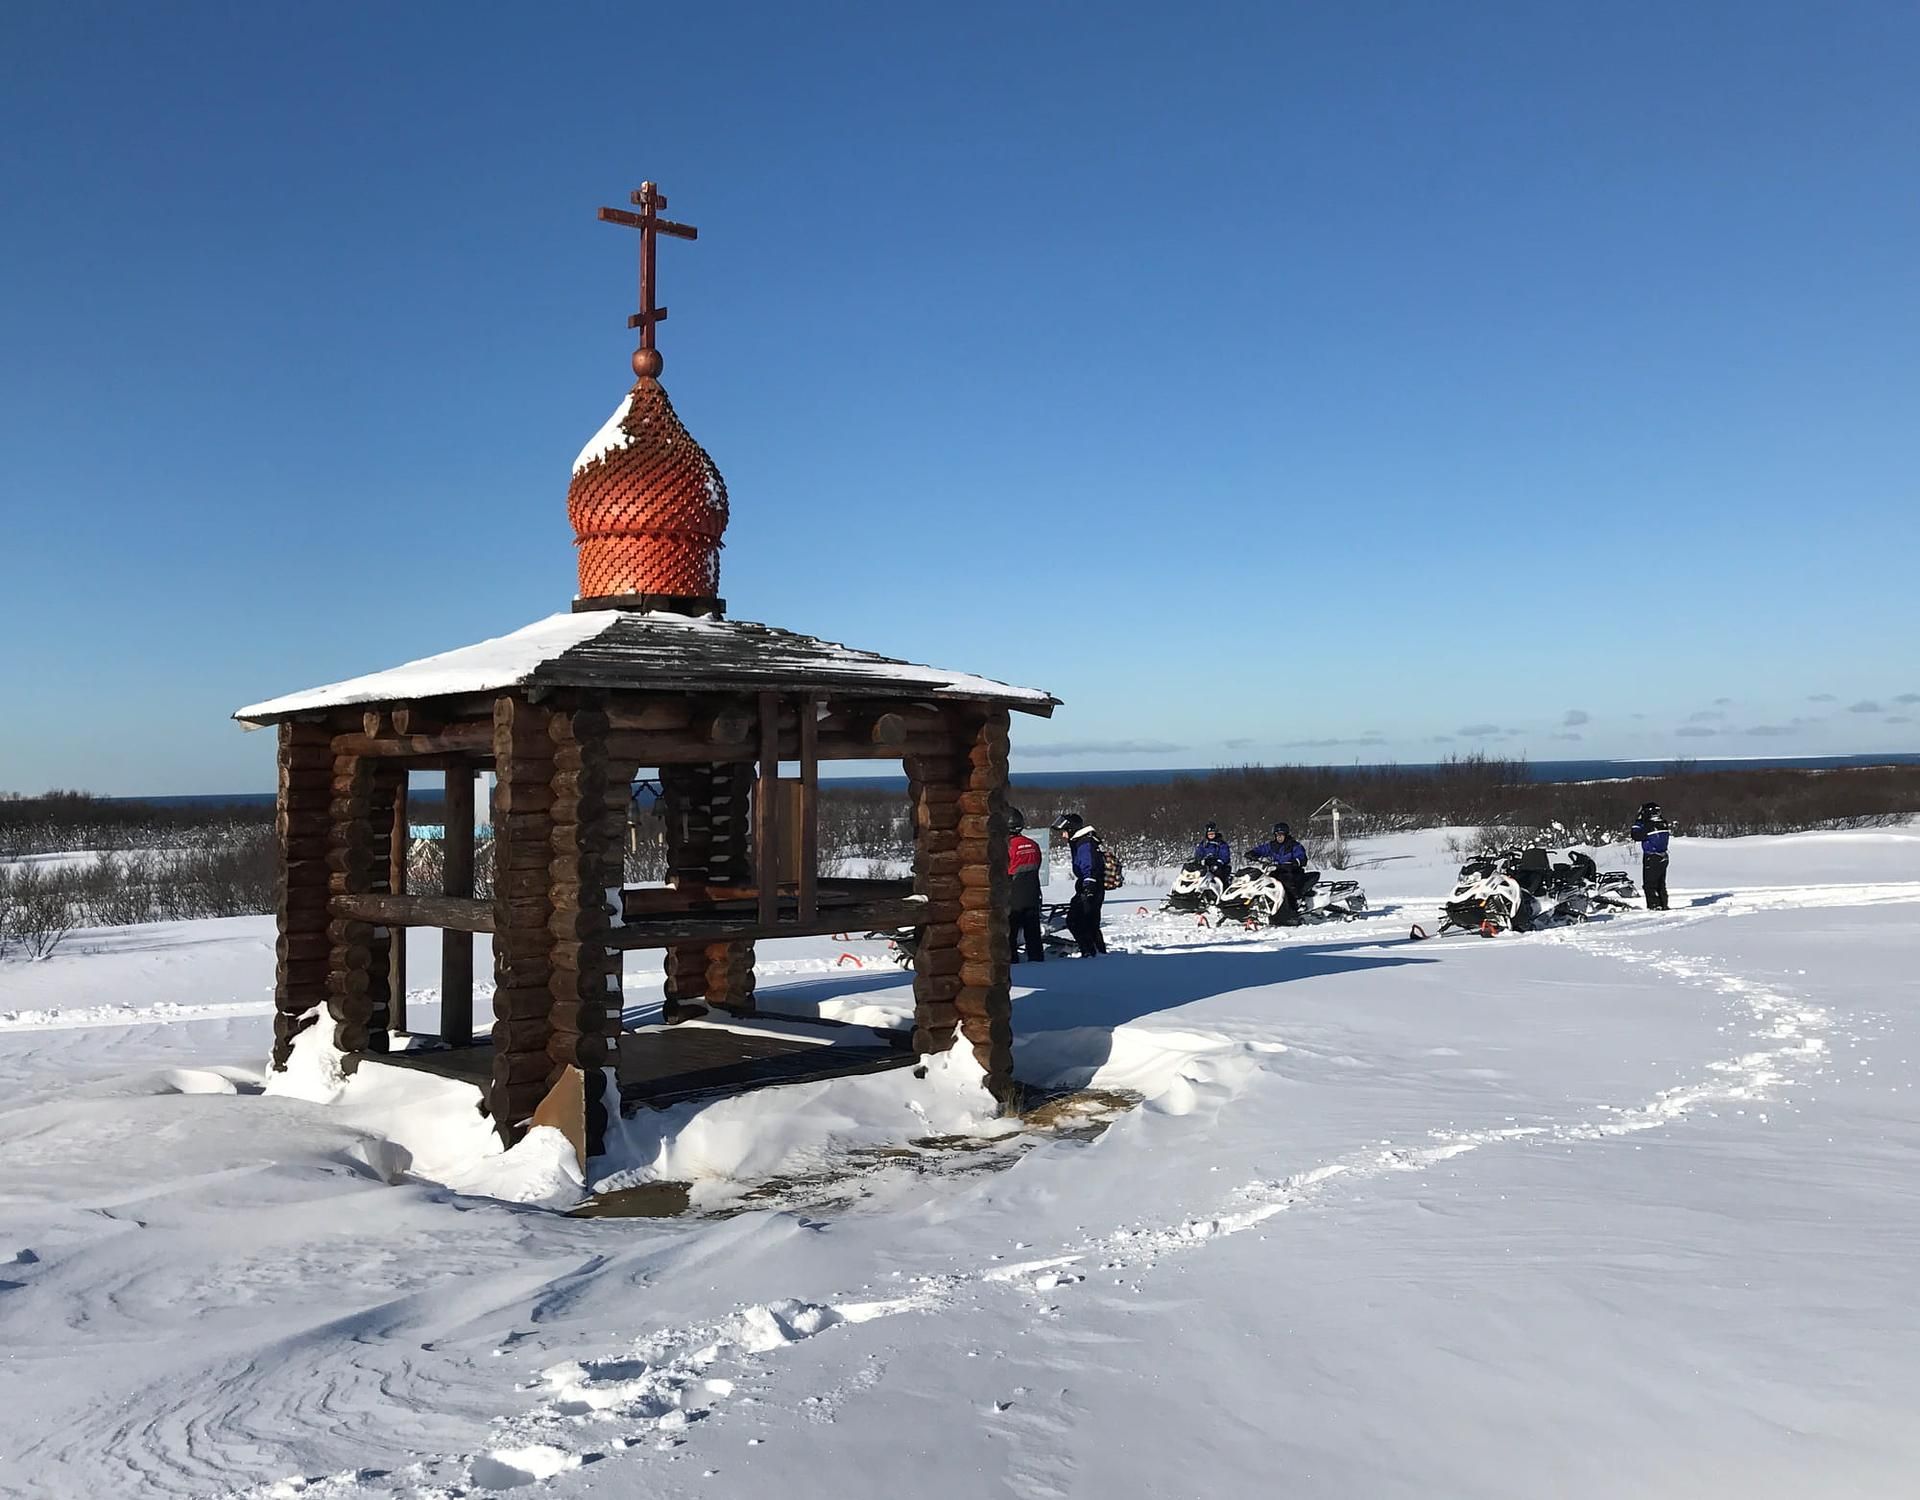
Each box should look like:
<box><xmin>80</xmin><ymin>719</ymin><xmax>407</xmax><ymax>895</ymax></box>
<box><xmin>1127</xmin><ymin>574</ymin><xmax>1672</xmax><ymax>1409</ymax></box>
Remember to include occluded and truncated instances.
<box><xmin>566</xmin><ymin>370</ymin><xmax>728</xmax><ymax>609</ymax></box>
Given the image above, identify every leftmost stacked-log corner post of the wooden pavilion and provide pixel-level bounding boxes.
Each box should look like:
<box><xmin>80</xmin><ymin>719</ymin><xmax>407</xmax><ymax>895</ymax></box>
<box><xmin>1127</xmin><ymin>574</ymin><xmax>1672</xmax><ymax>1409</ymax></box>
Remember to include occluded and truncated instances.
<box><xmin>273</xmin><ymin>722</ymin><xmax>334</xmax><ymax>1070</ymax></box>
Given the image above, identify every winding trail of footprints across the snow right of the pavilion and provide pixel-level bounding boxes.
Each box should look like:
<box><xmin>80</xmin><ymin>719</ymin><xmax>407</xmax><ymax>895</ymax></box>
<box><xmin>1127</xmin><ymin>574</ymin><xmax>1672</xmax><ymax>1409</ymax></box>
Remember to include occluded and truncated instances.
<box><xmin>217</xmin><ymin>882</ymin><xmax>1920</xmax><ymax>1500</ymax></box>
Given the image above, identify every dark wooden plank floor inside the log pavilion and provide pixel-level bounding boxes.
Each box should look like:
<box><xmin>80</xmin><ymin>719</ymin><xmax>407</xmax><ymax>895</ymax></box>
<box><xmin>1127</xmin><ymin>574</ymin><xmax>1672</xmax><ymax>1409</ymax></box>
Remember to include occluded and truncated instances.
<box><xmin>378</xmin><ymin>1016</ymin><xmax>920</xmax><ymax>1114</ymax></box>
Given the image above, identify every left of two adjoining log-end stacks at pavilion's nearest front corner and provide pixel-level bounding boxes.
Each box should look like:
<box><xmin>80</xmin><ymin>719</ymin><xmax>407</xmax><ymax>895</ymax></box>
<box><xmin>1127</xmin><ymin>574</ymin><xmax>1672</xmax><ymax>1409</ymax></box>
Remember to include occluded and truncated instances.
<box><xmin>488</xmin><ymin>695</ymin><xmax>557</xmax><ymax>1145</ymax></box>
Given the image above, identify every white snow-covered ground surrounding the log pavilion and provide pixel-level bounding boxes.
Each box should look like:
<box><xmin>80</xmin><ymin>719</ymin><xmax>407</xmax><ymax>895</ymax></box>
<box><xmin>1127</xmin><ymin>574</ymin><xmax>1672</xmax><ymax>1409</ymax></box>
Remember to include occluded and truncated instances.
<box><xmin>0</xmin><ymin>830</ymin><xmax>1920</xmax><ymax>1500</ymax></box>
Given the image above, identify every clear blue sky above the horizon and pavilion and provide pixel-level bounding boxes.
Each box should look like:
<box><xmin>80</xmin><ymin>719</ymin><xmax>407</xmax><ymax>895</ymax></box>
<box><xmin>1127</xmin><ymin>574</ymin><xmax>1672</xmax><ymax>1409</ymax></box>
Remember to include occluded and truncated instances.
<box><xmin>0</xmin><ymin>4</ymin><xmax>1920</xmax><ymax>793</ymax></box>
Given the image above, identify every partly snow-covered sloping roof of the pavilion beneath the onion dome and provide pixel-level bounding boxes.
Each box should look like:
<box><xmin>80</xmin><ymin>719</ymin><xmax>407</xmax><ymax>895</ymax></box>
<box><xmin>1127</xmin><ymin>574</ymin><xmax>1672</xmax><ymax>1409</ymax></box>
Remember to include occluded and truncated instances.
<box><xmin>234</xmin><ymin>609</ymin><xmax>1058</xmax><ymax>724</ymax></box>
